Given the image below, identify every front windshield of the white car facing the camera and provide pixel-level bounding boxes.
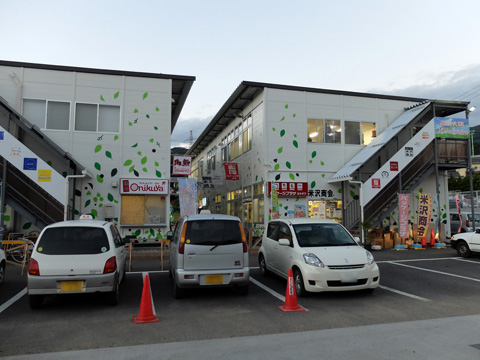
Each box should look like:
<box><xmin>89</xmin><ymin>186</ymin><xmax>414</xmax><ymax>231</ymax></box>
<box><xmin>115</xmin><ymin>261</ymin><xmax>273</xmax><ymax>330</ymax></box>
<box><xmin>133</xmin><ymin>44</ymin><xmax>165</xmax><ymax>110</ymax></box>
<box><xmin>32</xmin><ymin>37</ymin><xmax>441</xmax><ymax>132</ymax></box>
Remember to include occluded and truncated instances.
<box><xmin>293</xmin><ymin>224</ymin><xmax>357</xmax><ymax>247</ymax></box>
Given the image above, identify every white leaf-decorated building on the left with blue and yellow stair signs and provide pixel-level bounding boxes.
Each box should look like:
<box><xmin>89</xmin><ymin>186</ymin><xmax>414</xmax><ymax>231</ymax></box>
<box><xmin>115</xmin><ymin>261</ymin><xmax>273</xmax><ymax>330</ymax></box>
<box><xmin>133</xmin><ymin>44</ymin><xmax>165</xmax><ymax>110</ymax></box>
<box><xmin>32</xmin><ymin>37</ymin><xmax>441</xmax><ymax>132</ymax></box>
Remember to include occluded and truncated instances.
<box><xmin>0</xmin><ymin>61</ymin><xmax>195</xmax><ymax>239</ymax></box>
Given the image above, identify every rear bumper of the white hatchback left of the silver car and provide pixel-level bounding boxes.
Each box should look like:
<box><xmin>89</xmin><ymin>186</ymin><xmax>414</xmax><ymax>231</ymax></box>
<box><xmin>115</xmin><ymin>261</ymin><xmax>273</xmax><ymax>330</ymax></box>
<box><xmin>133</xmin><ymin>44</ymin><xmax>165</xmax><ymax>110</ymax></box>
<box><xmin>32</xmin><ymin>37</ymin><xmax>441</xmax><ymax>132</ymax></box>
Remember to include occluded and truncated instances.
<box><xmin>27</xmin><ymin>272</ymin><xmax>119</xmax><ymax>295</ymax></box>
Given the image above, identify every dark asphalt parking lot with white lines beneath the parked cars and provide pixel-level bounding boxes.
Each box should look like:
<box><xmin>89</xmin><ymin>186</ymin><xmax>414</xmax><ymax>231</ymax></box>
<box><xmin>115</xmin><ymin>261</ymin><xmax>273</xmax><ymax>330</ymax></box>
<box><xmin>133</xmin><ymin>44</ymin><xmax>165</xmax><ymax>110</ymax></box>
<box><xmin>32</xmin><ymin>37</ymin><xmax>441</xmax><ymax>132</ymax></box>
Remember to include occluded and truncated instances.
<box><xmin>0</xmin><ymin>248</ymin><xmax>480</xmax><ymax>356</ymax></box>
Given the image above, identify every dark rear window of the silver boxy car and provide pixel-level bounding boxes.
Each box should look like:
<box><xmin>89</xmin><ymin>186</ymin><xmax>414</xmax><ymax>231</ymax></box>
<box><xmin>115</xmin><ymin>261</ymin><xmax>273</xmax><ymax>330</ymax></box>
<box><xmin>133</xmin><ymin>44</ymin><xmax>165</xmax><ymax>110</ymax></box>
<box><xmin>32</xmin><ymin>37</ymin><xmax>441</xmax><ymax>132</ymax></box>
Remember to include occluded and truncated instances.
<box><xmin>185</xmin><ymin>220</ymin><xmax>242</xmax><ymax>245</ymax></box>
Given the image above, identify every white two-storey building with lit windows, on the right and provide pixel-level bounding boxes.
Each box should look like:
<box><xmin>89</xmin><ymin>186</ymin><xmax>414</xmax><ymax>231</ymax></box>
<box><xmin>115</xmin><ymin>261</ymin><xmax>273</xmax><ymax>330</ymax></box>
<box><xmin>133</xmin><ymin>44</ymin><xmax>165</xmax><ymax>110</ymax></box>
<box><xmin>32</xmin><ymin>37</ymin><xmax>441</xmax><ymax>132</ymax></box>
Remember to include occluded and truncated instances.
<box><xmin>187</xmin><ymin>81</ymin><xmax>469</xmax><ymax>239</ymax></box>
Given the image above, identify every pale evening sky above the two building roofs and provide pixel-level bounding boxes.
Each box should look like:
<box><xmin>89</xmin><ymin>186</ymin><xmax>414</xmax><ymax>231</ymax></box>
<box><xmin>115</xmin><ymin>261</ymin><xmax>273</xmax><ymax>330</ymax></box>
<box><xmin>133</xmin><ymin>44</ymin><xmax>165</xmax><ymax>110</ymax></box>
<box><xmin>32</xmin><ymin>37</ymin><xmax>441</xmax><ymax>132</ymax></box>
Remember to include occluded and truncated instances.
<box><xmin>0</xmin><ymin>0</ymin><xmax>480</xmax><ymax>146</ymax></box>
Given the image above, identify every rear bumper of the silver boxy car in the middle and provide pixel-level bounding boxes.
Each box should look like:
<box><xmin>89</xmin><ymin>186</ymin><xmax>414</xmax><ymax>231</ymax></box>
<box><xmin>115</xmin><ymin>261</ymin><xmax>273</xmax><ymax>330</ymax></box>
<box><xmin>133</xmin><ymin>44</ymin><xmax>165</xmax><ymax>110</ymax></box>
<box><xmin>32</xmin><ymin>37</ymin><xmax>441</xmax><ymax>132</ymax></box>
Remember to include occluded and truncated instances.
<box><xmin>174</xmin><ymin>267</ymin><xmax>250</xmax><ymax>288</ymax></box>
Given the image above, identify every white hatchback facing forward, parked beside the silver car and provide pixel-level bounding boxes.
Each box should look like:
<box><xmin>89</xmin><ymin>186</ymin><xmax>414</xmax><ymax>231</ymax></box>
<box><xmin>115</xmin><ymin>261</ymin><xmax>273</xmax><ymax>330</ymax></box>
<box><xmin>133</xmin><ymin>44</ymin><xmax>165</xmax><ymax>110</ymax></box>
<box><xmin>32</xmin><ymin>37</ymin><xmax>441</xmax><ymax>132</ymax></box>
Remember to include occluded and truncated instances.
<box><xmin>258</xmin><ymin>218</ymin><xmax>380</xmax><ymax>296</ymax></box>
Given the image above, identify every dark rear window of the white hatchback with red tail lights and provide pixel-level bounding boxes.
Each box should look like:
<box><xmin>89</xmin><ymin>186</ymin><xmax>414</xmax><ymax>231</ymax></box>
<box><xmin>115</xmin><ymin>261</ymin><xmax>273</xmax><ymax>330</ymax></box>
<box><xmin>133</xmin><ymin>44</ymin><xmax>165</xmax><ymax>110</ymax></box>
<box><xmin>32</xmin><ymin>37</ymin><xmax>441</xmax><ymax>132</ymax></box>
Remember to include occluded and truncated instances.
<box><xmin>37</xmin><ymin>226</ymin><xmax>110</xmax><ymax>255</ymax></box>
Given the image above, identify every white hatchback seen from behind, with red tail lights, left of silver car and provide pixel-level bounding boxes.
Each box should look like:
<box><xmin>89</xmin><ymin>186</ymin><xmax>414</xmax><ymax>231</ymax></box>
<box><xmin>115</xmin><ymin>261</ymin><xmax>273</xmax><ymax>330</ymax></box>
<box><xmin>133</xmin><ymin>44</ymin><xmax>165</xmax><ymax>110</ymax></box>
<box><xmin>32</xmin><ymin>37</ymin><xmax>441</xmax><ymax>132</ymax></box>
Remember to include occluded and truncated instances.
<box><xmin>27</xmin><ymin>217</ymin><xmax>126</xmax><ymax>309</ymax></box>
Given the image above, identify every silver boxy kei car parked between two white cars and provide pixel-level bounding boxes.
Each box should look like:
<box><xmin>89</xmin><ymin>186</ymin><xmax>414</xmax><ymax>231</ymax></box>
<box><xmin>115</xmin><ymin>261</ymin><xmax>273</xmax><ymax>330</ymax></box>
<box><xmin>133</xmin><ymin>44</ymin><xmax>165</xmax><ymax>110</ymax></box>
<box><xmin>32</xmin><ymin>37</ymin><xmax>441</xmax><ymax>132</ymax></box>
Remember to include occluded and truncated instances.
<box><xmin>168</xmin><ymin>211</ymin><xmax>250</xmax><ymax>298</ymax></box>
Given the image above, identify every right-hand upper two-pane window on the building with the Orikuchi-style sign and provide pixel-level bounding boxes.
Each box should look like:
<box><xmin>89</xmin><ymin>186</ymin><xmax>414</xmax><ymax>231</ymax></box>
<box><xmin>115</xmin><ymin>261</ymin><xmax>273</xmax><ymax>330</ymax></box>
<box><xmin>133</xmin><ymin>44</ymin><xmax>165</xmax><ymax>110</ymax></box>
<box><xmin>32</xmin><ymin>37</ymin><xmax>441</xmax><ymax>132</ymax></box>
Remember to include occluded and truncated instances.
<box><xmin>75</xmin><ymin>103</ymin><xmax>120</xmax><ymax>133</ymax></box>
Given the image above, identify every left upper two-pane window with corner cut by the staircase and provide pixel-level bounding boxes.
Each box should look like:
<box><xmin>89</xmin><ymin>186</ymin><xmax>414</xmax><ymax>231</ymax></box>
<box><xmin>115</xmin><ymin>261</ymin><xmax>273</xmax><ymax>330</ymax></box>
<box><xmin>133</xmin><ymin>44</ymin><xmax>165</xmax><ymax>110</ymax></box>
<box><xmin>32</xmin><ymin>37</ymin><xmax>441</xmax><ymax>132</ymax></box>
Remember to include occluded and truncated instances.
<box><xmin>23</xmin><ymin>99</ymin><xmax>70</xmax><ymax>130</ymax></box>
